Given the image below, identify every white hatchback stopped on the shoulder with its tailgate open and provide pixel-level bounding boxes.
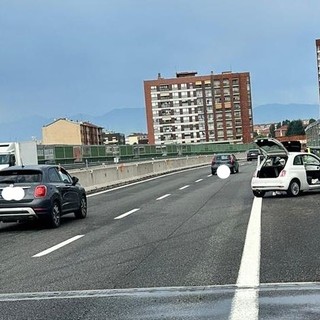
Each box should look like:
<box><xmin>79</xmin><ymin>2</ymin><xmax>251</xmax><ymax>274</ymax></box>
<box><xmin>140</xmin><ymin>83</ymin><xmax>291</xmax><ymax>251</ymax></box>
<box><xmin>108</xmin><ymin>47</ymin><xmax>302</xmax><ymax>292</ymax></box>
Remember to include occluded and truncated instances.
<box><xmin>251</xmin><ymin>138</ymin><xmax>320</xmax><ymax>197</ymax></box>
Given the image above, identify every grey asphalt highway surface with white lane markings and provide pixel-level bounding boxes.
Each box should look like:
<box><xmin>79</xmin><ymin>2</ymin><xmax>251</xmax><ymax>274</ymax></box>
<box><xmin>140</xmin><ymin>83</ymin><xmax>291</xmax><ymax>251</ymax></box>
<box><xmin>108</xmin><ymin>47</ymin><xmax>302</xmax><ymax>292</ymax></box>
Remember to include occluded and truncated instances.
<box><xmin>0</xmin><ymin>162</ymin><xmax>320</xmax><ymax>319</ymax></box>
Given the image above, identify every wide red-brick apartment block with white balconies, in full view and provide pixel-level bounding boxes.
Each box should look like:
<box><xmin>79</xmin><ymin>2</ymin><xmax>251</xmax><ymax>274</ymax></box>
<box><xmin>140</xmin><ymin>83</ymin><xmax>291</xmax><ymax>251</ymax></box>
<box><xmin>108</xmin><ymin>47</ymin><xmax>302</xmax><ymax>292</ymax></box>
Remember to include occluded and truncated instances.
<box><xmin>144</xmin><ymin>72</ymin><xmax>253</xmax><ymax>144</ymax></box>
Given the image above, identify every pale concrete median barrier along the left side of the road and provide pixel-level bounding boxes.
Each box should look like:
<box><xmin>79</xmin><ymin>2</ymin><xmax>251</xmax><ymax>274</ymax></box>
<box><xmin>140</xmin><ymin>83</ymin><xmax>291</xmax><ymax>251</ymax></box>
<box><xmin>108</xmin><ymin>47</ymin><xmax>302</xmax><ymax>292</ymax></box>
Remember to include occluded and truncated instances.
<box><xmin>69</xmin><ymin>156</ymin><xmax>212</xmax><ymax>191</ymax></box>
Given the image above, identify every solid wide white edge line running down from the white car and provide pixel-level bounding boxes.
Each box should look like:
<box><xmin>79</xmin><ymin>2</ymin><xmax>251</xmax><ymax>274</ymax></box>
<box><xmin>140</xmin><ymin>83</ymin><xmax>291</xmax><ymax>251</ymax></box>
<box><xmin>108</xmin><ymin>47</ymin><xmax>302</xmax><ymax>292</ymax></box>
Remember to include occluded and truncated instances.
<box><xmin>229</xmin><ymin>197</ymin><xmax>262</xmax><ymax>320</ymax></box>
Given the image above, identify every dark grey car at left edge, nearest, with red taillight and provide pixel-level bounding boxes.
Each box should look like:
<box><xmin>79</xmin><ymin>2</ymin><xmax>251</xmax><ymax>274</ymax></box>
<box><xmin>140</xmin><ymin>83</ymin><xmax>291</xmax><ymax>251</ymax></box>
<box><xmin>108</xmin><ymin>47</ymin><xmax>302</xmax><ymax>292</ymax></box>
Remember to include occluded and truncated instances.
<box><xmin>0</xmin><ymin>165</ymin><xmax>87</xmax><ymax>228</ymax></box>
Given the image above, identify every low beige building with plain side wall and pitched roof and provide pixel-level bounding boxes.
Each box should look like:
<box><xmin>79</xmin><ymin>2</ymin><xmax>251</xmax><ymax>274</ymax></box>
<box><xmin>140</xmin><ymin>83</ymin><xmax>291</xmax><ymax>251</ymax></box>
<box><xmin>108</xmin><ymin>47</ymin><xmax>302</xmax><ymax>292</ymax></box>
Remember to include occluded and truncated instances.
<box><xmin>42</xmin><ymin>118</ymin><xmax>103</xmax><ymax>145</ymax></box>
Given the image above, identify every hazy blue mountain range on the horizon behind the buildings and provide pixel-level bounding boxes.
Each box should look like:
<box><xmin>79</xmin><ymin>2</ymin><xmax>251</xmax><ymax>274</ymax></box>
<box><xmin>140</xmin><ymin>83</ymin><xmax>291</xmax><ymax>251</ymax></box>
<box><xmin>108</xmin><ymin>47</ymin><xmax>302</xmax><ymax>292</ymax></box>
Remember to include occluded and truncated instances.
<box><xmin>0</xmin><ymin>104</ymin><xmax>319</xmax><ymax>142</ymax></box>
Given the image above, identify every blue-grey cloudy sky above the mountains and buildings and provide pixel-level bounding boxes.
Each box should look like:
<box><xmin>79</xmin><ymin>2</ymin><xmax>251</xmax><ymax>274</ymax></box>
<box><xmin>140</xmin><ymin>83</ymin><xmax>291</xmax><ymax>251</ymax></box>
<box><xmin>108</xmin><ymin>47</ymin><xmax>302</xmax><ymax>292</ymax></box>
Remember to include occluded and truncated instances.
<box><xmin>0</xmin><ymin>0</ymin><xmax>320</xmax><ymax>122</ymax></box>
